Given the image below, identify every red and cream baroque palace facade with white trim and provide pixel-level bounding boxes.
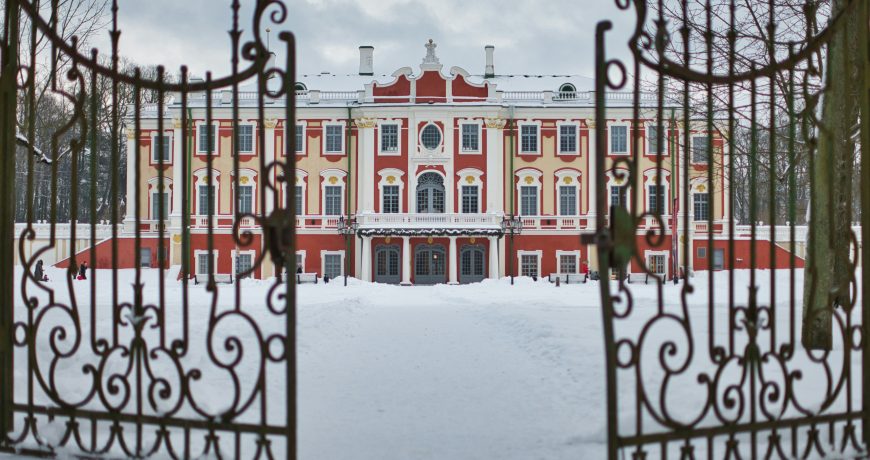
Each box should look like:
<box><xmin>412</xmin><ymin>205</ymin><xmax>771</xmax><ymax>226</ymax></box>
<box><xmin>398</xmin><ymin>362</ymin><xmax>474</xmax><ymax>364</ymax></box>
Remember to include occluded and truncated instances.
<box><xmin>85</xmin><ymin>40</ymin><xmax>800</xmax><ymax>284</ymax></box>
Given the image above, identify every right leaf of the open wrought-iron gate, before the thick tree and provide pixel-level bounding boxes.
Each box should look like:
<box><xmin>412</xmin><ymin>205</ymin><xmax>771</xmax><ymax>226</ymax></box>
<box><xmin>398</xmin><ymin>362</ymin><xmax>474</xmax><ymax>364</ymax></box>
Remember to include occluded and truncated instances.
<box><xmin>589</xmin><ymin>0</ymin><xmax>870</xmax><ymax>459</ymax></box>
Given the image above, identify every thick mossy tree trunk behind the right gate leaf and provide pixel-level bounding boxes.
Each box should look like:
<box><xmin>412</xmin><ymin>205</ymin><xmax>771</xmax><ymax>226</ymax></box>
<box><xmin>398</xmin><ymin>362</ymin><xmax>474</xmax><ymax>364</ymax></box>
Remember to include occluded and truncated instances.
<box><xmin>801</xmin><ymin>0</ymin><xmax>859</xmax><ymax>350</ymax></box>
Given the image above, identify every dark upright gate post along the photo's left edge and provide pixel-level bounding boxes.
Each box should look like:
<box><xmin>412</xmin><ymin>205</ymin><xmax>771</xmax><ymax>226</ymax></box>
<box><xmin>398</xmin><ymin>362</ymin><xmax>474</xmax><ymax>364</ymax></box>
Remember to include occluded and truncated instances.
<box><xmin>0</xmin><ymin>0</ymin><xmax>19</xmax><ymax>445</ymax></box>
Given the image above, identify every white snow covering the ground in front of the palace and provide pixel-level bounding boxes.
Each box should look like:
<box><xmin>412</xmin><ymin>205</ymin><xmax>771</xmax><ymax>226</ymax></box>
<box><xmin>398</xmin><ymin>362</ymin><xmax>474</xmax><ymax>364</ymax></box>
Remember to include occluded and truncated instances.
<box><xmin>16</xmin><ymin>268</ymin><xmax>860</xmax><ymax>459</ymax></box>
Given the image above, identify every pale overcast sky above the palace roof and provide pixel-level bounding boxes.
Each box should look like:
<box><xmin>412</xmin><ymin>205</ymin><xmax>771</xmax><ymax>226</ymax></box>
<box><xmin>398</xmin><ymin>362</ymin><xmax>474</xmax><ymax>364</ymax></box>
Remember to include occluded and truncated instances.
<box><xmin>94</xmin><ymin>0</ymin><xmax>634</xmax><ymax>77</ymax></box>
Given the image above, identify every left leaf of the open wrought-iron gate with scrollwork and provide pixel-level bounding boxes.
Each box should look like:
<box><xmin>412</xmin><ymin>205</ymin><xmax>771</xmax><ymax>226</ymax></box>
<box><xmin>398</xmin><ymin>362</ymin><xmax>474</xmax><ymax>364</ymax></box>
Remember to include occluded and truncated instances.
<box><xmin>0</xmin><ymin>0</ymin><xmax>296</xmax><ymax>458</ymax></box>
